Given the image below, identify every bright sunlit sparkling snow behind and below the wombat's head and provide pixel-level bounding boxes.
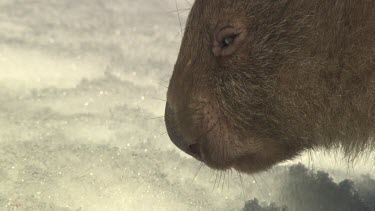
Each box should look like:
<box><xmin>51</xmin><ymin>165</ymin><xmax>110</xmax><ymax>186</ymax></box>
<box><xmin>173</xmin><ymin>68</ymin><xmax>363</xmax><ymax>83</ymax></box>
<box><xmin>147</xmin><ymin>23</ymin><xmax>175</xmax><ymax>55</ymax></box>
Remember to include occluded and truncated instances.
<box><xmin>0</xmin><ymin>0</ymin><xmax>375</xmax><ymax>211</ymax></box>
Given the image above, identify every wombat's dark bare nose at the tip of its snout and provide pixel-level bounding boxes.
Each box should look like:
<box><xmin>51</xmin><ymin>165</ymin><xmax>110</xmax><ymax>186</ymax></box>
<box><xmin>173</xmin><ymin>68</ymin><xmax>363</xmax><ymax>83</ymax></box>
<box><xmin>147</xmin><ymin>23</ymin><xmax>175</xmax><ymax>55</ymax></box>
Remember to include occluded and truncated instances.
<box><xmin>164</xmin><ymin>102</ymin><xmax>202</xmax><ymax>160</ymax></box>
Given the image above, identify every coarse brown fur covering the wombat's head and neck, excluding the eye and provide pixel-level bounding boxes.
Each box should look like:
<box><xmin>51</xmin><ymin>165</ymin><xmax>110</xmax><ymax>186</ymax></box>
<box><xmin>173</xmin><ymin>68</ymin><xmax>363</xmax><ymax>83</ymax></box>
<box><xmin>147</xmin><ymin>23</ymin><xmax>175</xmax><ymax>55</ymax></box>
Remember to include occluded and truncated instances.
<box><xmin>166</xmin><ymin>0</ymin><xmax>375</xmax><ymax>173</ymax></box>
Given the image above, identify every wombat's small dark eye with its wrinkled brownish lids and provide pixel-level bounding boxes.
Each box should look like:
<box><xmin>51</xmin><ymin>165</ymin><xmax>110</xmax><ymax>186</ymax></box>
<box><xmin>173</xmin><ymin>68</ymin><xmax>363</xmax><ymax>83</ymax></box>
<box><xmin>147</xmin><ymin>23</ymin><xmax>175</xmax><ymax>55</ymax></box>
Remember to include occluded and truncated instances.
<box><xmin>212</xmin><ymin>26</ymin><xmax>246</xmax><ymax>57</ymax></box>
